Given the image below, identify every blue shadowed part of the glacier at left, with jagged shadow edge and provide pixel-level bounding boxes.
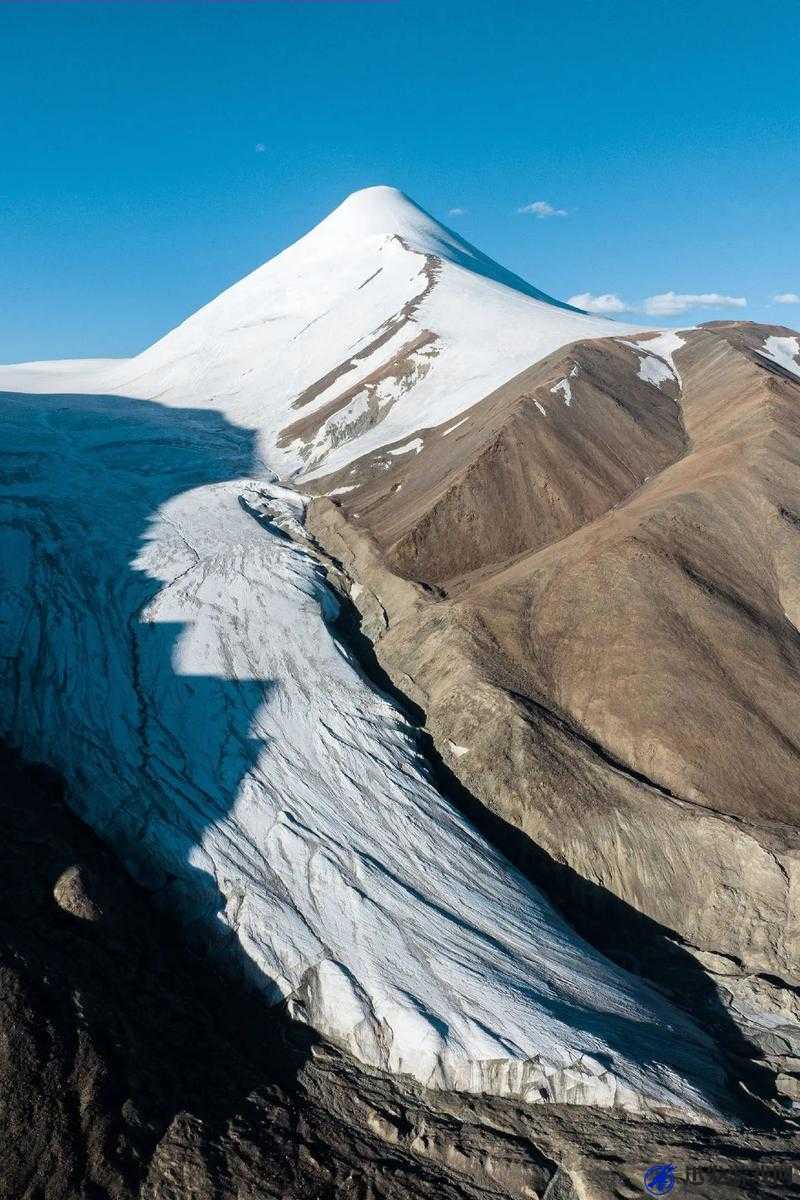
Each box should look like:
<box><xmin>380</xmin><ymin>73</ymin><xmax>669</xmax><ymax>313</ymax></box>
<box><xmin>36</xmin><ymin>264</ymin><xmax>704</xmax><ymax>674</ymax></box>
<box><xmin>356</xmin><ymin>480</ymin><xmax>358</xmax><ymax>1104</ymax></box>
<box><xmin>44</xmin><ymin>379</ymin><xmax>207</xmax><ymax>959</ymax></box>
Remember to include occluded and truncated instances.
<box><xmin>0</xmin><ymin>392</ymin><xmax>278</xmax><ymax>983</ymax></box>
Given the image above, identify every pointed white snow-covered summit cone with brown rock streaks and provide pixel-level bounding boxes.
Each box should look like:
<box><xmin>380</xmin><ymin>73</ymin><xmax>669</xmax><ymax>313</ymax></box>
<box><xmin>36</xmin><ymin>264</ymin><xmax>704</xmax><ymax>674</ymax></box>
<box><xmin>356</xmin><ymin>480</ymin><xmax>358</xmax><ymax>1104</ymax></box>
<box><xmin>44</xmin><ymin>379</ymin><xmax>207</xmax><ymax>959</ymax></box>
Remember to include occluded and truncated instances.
<box><xmin>0</xmin><ymin>187</ymin><xmax>634</xmax><ymax>479</ymax></box>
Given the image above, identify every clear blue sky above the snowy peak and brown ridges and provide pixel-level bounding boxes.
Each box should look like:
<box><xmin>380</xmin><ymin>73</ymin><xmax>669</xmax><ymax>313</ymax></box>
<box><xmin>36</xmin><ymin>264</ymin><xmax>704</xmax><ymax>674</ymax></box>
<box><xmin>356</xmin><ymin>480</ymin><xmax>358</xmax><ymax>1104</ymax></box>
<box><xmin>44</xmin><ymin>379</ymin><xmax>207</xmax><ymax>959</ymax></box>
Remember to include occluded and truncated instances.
<box><xmin>0</xmin><ymin>0</ymin><xmax>800</xmax><ymax>361</ymax></box>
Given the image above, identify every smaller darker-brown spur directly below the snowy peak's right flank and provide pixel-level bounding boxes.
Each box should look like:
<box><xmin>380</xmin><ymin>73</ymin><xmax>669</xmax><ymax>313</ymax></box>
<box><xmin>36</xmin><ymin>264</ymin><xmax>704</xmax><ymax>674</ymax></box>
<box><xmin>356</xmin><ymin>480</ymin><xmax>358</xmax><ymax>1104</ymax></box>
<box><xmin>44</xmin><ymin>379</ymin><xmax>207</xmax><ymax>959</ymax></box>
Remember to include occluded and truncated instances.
<box><xmin>312</xmin><ymin>341</ymin><xmax>686</xmax><ymax>582</ymax></box>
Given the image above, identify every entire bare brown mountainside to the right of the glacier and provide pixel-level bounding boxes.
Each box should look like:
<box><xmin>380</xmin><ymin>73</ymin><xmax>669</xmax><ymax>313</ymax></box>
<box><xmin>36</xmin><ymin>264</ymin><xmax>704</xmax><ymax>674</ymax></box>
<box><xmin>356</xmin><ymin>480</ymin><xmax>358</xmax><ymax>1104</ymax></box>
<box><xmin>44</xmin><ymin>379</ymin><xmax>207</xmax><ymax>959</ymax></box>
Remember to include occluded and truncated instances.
<box><xmin>304</xmin><ymin>323</ymin><xmax>800</xmax><ymax>1094</ymax></box>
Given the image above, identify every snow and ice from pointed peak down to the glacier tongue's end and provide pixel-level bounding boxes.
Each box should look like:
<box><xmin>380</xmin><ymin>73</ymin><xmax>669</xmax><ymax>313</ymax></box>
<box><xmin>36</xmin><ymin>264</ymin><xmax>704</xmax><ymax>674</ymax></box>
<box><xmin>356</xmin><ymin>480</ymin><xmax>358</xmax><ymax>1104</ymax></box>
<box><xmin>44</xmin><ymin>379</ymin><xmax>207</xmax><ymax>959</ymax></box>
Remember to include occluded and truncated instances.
<box><xmin>0</xmin><ymin>190</ymin><xmax>722</xmax><ymax>1111</ymax></box>
